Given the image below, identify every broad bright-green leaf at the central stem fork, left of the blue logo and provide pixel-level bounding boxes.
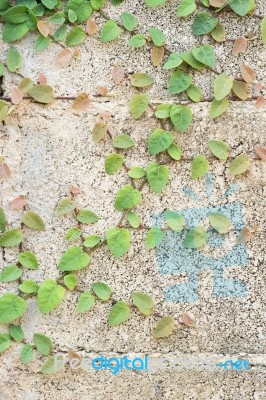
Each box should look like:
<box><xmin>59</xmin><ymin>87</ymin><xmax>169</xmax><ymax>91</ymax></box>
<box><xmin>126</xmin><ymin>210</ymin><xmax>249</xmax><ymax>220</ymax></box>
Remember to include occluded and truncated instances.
<box><xmin>106</xmin><ymin>227</ymin><xmax>130</xmax><ymax>258</ymax></box>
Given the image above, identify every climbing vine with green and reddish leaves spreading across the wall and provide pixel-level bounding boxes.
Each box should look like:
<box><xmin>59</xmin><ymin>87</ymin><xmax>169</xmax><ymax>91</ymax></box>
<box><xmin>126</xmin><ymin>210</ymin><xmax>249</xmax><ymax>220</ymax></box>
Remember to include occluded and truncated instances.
<box><xmin>0</xmin><ymin>0</ymin><xmax>266</xmax><ymax>373</ymax></box>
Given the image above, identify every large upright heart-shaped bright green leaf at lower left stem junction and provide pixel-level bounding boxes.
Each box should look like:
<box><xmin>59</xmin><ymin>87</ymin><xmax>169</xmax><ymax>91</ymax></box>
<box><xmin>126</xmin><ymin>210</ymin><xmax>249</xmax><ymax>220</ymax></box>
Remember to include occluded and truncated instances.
<box><xmin>37</xmin><ymin>279</ymin><xmax>65</xmax><ymax>314</ymax></box>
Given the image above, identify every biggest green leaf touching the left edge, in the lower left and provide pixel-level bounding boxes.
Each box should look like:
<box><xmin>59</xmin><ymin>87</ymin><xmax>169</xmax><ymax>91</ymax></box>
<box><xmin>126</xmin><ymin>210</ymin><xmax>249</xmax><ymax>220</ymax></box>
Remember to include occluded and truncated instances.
<box><xmin>0</xmin><ymin>293</ymin><xmax>27</xmax><ymax>324</ymax></box>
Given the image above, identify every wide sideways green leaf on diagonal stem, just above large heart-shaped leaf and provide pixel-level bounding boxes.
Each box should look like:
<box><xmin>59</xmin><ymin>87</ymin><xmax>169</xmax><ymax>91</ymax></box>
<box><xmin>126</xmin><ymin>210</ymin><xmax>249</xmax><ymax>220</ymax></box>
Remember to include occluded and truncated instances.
<box><xmin>58</xmin><ymin>246</ymin><xmax>91</xmax><ymax>271</ymax></box>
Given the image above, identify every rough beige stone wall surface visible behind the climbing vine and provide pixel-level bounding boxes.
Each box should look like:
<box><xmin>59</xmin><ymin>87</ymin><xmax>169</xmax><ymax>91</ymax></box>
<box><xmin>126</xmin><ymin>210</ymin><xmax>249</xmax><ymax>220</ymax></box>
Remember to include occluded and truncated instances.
<box><xmin>0</xmin><ymin>0</ymin><xmax>266</xmax><ymax>400</ymax></box>
